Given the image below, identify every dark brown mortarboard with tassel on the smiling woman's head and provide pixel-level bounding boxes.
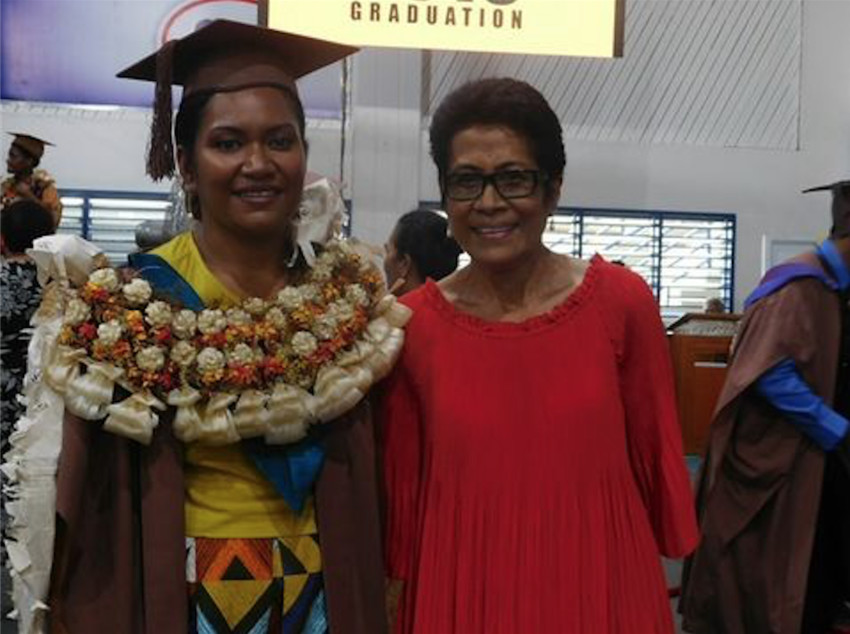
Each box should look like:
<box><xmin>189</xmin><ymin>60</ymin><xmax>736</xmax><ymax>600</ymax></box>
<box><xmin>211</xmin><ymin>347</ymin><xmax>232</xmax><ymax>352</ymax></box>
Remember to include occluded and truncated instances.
<box><xmin>118</xmin><ymin>20</ymin><xmax>358</xmax><ymax>180</ymax></box>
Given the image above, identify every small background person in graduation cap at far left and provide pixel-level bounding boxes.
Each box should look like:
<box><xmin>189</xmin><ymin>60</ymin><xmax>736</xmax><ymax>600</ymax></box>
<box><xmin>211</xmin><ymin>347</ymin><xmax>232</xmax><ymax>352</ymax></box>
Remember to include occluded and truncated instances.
<box><xmin>0</xmin><ymin>132</ymin><xmax>62</xmax><ymax>227</ymax></box>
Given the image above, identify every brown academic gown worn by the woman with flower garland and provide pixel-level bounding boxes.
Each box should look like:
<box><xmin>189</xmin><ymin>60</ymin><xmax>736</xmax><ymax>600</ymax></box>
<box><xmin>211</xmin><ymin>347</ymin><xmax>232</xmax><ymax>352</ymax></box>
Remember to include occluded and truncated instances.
<box><xmin>49</xmin><ymin>404</ymin><xmax>386</xmax><ymax>634</ymax></box>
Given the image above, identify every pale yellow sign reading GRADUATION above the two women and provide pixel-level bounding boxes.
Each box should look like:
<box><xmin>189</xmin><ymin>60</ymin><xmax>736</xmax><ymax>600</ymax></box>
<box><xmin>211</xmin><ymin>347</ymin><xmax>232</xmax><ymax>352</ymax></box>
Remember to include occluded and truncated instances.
<box><xmin>261</xmin><ymin>0</ymin><xmax>624</xmax><ymax>57</ymax></box>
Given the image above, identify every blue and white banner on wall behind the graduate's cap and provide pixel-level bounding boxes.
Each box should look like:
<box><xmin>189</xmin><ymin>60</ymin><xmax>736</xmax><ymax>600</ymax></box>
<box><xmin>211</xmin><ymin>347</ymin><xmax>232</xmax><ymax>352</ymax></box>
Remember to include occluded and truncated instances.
<box><xmin>0</xmin><ymin>0</ymin><xmax>342</xmax><ymax>119</ymax></box>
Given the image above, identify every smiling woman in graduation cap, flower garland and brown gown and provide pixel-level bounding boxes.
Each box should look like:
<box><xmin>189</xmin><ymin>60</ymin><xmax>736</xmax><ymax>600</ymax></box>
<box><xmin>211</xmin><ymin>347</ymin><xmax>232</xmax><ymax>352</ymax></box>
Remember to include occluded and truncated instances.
<box><xmin>19</xmin><ymin>20</ymin><xmax>409</xmax><ymax>634</ymax></box>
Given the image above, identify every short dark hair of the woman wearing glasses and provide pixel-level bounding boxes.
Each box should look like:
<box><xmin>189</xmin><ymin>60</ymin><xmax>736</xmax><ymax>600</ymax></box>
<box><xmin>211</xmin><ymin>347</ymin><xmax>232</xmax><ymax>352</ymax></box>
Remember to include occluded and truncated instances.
<box><xmin>430</xmin><ymin>77</ymin><xmax>567</xmax><ymax>195</ymax></box>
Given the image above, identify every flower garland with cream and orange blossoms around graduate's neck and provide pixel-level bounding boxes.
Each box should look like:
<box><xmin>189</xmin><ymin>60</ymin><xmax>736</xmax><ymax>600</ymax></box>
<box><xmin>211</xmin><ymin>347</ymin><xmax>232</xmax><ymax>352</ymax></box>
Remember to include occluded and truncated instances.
<box><xmin>44</xmin><ymin>240</ymin><xmax>410</xmax><ymax>444</ymax></box>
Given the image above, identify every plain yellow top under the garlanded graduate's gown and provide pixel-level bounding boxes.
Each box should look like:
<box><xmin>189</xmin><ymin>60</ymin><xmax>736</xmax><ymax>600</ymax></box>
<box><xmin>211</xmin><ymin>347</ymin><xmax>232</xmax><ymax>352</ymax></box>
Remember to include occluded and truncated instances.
<box><xmin>153</xmin><ymin>232</ymin><xmax>317</xmax><ymax>538</ymax></box>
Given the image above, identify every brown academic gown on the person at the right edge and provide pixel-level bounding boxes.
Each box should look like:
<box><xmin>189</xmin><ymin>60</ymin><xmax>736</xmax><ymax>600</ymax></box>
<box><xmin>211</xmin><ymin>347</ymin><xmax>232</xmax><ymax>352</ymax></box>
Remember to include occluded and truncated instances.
<box><xmin>680</xmin><ymin>254</ymin><xmax>841</xmax><ymax>634</ymax></box>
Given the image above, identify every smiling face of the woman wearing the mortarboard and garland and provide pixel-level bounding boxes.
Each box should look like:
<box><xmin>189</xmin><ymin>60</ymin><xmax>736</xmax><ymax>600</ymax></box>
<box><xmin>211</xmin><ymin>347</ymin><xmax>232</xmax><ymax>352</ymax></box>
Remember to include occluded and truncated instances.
<box><xmin>178</xmin><ymin>88</ymin><xmax>307</xmax><ymax>241</ymax></box>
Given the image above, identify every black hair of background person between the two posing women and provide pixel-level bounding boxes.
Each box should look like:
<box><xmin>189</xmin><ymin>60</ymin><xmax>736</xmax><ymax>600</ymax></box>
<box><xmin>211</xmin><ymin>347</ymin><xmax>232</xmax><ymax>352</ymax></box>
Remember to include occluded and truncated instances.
<box><xmin>394</xmin><ymin>209</ymin><xmax>462</xmax><ymax>280</ymax></box>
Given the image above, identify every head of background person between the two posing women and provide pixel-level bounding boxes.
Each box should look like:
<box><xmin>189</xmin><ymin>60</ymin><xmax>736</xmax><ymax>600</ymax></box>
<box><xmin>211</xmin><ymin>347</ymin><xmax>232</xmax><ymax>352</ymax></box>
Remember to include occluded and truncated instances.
<box><xmin>384</xmin><ymin>209</ymin><xmax>462</xmax><ymax>295</ymax></box>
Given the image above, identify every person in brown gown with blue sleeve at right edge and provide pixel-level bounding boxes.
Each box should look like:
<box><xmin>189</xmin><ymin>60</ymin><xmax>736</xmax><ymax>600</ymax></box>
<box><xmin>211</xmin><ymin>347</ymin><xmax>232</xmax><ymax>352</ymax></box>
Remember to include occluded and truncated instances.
<box><xmin>680</xmin><ymin>181</ymin><xmax>850</xmax><ymax>634</ymax></box>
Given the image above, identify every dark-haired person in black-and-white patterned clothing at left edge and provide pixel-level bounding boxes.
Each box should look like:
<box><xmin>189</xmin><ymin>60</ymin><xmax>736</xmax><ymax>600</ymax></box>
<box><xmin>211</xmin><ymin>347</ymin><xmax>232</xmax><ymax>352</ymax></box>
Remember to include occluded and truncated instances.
<box><xmin>0</xmin><ymin>200</ymin><xmax>53</xmax><ymax>453</ymax></box>
